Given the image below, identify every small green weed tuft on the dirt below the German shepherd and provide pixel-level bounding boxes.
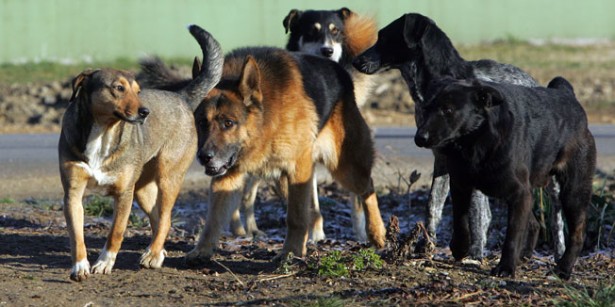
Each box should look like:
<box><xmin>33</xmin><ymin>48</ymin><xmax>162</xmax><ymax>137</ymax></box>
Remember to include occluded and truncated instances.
<box><xmin>308</xmin><ymin>248</ymin><xmax>384</xmax><ymax>277</ymax></box>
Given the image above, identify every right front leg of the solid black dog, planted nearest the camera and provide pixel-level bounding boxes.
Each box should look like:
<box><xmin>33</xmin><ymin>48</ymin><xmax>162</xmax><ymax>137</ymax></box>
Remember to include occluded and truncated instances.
<box><xmin>491</xmin><ymin>186</ymin><xmax>532</xmax><ymax>278</ymax></box>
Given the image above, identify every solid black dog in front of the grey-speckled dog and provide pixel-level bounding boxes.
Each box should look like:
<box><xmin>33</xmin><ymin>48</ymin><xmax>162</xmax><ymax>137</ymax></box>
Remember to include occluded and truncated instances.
<box><xmin>415</xmin><ymin>77</ymin><xmax>596</xmax><ymax>279</ymax></box>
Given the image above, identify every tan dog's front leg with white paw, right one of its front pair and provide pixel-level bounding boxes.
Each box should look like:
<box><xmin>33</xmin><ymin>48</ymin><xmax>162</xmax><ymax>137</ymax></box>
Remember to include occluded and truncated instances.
<box><xmin>92</xmin><ymin>190</ymin><xmax>134</xmax><ymax>274</ymax></box>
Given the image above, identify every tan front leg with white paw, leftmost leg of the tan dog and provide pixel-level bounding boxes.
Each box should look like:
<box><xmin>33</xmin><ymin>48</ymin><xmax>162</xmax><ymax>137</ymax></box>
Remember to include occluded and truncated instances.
<box><xmin>61</xmin><ymin>163</ymin><xmax>90</xmax><ymax>281</ymax></box>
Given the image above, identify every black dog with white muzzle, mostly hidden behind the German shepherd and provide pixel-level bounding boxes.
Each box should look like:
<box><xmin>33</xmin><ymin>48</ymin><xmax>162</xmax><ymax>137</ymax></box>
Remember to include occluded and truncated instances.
<box><xmin>137</xmin><ymin>8</ymin><xmax>377</xmax><ymax>242</ymax></box>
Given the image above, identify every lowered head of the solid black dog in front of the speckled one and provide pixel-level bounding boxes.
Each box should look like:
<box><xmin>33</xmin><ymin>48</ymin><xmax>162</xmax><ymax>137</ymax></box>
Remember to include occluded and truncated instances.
<box><xmin>414</xmin><ymin>79</ymin><xmax>504</xmax><ymax>148</ymax></box>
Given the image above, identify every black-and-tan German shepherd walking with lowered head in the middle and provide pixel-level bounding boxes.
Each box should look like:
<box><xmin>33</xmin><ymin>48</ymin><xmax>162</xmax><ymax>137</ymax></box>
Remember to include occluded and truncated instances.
<box><xmin>186</xmin><ymin>47</ymin><xmax>385</xmax><ymax>264</ymax></box>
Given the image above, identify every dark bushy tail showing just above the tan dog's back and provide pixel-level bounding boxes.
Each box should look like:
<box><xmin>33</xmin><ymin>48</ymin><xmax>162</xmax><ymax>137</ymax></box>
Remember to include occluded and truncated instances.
<box><xmin>137</xmin><ymin>57</ymin><xmax>191</xmax><ymax>92</ymax></box>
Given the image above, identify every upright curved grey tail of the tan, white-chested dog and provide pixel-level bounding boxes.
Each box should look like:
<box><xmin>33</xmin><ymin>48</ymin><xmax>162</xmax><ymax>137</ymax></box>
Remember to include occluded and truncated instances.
<box><xmin>179</xmin><ymin>25</ymin><xmax>224</xmax><ymax>110</ymax></box>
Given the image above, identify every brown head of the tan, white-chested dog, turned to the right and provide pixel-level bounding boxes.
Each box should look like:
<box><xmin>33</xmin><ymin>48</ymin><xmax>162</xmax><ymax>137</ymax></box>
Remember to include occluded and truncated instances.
<box><xmin>70</xmin><ymin>69</ymin><xmax>150</xmax><ymax>125</ymax></box>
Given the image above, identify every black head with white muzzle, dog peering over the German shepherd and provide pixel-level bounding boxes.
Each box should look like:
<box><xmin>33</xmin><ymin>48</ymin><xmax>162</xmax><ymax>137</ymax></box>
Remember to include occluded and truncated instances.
<box><xmin>283</xmin><ymin>8</ymin><xmax>353</xmax><ymax>62</ymax></box>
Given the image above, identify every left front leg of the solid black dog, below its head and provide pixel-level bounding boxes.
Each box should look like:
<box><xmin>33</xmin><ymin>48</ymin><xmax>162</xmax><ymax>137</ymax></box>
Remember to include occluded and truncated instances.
<box><xmin>450</xmin><ymin>183</ymin><xmax>472</xmax><ymax>261</ymax></box>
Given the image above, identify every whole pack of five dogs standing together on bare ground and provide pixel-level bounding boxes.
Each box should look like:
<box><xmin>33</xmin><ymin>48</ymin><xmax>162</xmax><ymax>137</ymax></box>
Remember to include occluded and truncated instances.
<box><xmin>58</xmin><ymin>8</ymin><xmax>596</xmax><ymax>281</ymax></box>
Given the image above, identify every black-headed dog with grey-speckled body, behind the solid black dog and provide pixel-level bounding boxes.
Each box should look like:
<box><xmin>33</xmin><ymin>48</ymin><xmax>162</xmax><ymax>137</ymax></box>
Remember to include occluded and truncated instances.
<box><xmin>353</xmin><ymin>13</ymin><xmax>563</xmax><ymax>259</ymax></box>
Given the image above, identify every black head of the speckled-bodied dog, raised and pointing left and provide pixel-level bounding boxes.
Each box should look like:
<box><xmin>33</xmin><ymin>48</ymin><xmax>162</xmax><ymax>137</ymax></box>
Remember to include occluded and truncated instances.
<box><xmin>353</xmin><ymin>13</ymin><xmax>436</xmax><ymax>74</ymax></box>
